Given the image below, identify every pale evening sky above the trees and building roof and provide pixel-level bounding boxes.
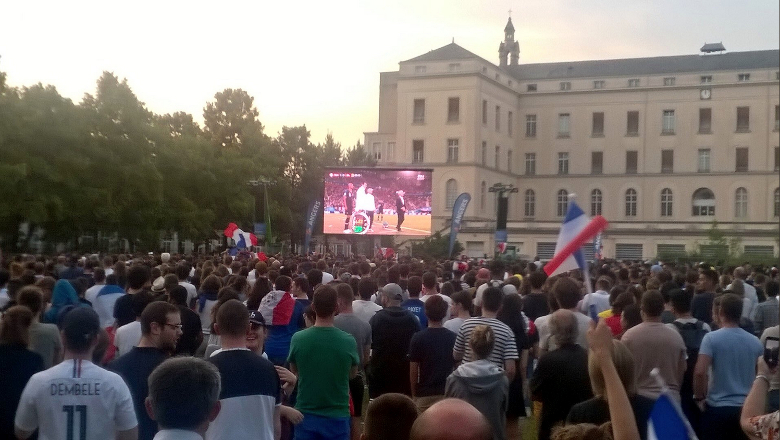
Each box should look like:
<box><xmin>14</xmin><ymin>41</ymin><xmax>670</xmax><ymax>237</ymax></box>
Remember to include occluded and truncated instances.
<box><xmin>0</xmin><ymin>0</ymin><xmax>780</xmax><ymax>147</ymax></box>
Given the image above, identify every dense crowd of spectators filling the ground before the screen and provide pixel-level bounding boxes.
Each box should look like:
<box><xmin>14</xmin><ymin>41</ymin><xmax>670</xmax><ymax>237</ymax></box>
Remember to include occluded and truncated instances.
<box><xmin>0</xmin><ymin>253</ymin><xmax>780</xmax><ymax>440</ymax></box>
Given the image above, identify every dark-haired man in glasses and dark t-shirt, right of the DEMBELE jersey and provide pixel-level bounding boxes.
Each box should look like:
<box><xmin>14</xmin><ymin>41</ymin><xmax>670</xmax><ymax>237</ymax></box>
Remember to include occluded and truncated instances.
<box><xmin>107</xmin><ymin>301</ymin><xmax>182</xmax><ymax>440</ymax></box>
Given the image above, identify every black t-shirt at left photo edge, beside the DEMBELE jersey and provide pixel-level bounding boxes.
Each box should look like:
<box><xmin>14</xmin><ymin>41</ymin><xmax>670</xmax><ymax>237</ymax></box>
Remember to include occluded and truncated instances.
<box><xmin>0</xmin><ymin>344</ymin><xmax>44</xmax><ymax>438</ymax></box>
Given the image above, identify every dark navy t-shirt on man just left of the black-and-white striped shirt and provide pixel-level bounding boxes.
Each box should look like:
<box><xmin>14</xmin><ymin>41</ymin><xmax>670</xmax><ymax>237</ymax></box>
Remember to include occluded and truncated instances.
<box><xmin>409</xmin><ymin>327</ymin><xmax>455</xmax><ymax>397</ymax></box>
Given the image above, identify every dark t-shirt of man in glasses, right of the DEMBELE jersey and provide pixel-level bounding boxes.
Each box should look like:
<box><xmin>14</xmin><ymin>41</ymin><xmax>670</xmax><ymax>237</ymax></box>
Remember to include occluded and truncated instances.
<box><xmin>106</xmin><ymin>347</ymin><xmax>168</xmax><ymax>440</ymax></box>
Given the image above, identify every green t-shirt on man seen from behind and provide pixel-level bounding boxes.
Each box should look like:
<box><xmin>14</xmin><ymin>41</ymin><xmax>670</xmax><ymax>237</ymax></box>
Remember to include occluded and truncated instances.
<box><xmin>287</xmin><ymin>327</ymin><xmax>359</xmax><ymax>417</ymax></box>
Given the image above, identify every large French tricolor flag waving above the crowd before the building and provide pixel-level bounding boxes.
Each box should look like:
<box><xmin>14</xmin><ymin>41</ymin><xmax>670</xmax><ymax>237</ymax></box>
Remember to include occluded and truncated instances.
<box><xmin>544</xmin><ymin>198</ymin><xmax>608</xmax><ymax>276</ymax></box>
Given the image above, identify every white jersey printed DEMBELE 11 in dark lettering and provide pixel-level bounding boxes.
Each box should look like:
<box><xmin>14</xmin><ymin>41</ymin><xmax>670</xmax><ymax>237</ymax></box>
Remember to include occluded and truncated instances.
<box><xmin>15</xmin><ymin>359</ymin><xmax>138</xmax><ymax>440</ymax></box>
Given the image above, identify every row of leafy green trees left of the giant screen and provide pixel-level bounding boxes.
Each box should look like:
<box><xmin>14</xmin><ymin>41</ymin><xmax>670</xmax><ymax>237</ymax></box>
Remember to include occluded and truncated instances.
<box><xmin>0</xmin><ymin>66</ymin><xmax>375</xmax><ymax>251</ymax></box>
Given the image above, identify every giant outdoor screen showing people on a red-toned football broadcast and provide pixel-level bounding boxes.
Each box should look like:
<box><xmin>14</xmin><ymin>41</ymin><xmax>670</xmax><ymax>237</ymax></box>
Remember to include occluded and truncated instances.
<box><xmin>322</xmin><ymin>168</ymin><xmax>433</xmax><ymax>236</ymax></box>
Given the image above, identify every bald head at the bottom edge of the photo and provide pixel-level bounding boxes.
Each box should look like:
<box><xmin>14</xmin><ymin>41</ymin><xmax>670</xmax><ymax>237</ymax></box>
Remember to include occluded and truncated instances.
<box><xmin>410</xmin><ymin>399</ymin><xmax>493</xmax><ymax>440</ymax></box>
